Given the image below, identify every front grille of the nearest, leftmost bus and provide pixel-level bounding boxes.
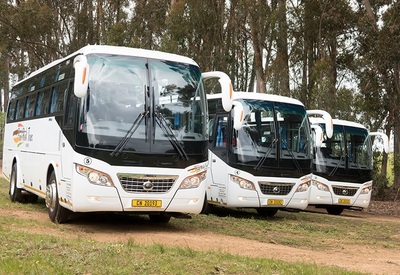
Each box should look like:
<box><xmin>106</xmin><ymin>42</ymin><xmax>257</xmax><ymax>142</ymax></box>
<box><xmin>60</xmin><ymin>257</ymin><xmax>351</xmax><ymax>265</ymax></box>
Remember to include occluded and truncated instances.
<box><xmin>118</xmin><ymin>174</ymin><xmax>178</xmax><ymax>193</ymax></box>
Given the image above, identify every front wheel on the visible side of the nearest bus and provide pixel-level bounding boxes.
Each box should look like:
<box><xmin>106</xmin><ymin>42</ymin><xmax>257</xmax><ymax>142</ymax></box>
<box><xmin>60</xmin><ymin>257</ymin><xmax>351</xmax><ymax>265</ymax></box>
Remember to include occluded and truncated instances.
<box><xmin>46</xmin><ymin>171</ymin><xmax>69</xmax><ymax>223</ymax></box>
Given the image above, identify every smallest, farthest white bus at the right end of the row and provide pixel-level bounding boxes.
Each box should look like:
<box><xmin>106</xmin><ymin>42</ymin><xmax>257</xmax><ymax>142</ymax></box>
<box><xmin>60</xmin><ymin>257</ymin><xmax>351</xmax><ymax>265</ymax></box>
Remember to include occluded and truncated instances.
<box><xmin>309</xmin><ymin>116</ymin><xmax>388</xmax><ymax>215</ymax></box>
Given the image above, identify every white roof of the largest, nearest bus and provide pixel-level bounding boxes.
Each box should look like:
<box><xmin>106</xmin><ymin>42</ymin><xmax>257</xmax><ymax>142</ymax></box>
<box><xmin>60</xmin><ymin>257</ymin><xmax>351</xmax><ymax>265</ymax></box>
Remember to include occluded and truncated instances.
<box><xmin>15</xmin><ymin>45</ymin><xmax>198</xmax><ymax>85</ymax></box>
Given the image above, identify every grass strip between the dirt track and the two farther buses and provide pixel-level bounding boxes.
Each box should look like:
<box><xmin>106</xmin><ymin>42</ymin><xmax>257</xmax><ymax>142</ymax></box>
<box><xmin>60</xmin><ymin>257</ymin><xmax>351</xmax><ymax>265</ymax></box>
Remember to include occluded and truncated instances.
<box><xmin>175</xmin><ymin>208</ymin><xmax>400</xmax><ymax>250</ymax></box>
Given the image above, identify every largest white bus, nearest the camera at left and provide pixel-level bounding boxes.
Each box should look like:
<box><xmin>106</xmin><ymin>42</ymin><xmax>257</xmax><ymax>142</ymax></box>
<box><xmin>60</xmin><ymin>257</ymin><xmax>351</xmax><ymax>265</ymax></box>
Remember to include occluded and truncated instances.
<box><xmin>3</xmin><ymin>46</ymin><xmax>232</xmax><ymax>223</ymax></box>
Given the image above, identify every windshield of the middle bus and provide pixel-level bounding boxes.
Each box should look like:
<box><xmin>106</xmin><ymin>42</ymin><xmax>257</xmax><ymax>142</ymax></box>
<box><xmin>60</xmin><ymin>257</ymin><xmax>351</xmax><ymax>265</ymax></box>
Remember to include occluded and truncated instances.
<box><xmin>232</xmin><ymin>100</ymin><xmax>311</xmax><ymax>167</ymax></box>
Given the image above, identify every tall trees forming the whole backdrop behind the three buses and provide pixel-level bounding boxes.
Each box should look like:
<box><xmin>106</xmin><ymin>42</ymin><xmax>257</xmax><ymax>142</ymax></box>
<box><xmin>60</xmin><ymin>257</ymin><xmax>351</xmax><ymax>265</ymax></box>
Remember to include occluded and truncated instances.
<box><xmin>0</xmin><ymin>0</ymin><xmax>400</xmax><ymax>198</ymax></box>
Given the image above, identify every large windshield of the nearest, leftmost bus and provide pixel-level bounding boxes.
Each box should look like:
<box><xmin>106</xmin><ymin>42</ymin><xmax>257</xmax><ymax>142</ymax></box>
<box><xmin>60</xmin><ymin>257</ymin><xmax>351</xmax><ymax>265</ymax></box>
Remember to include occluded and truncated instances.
<box><xmin>77</xmin><ymin>54</ymin><xmax>207</xmax><ymax>156</ymax></box>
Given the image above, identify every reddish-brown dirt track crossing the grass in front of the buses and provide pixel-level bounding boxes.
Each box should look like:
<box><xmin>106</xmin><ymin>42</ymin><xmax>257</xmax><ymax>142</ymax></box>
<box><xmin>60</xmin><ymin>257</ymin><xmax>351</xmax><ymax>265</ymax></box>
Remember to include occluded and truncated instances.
<box><xmin>0</xmin><ymin>163</ymin><xmax>400</xmax><ymax>274</ymax></box>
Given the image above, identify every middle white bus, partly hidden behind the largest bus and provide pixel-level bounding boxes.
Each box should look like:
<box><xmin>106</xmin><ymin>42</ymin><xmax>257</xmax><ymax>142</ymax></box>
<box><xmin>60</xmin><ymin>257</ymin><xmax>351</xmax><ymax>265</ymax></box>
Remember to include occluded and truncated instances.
<box><xmin>203</xmin><ymin>92</ymin><xmax>313</xmax><ymax>217</ymax></box>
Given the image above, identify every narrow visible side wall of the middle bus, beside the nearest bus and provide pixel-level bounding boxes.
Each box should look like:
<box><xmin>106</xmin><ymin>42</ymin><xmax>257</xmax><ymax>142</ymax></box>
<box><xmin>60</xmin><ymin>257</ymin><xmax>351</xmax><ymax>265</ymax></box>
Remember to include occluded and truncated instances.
<box><xmin>208</xmin><ymin>115</ymin><xmax>230</xmax><ymax>203</ymax></box>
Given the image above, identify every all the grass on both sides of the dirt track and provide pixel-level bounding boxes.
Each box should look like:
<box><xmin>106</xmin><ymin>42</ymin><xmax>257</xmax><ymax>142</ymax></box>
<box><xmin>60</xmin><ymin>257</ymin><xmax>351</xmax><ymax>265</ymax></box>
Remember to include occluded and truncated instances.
<box><xmin>0</xmin><ymin>179</ymin><xmax>394</xmax><ymax>274</ymax></box>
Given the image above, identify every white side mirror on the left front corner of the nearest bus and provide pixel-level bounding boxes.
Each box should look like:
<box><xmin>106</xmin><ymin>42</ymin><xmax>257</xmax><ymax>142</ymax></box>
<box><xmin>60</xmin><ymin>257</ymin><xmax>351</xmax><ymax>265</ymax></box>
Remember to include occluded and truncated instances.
<box><xmin>74</xmin><ymin>55</ymin><xmax>89</xmax><ymax>98</ymax></box>
